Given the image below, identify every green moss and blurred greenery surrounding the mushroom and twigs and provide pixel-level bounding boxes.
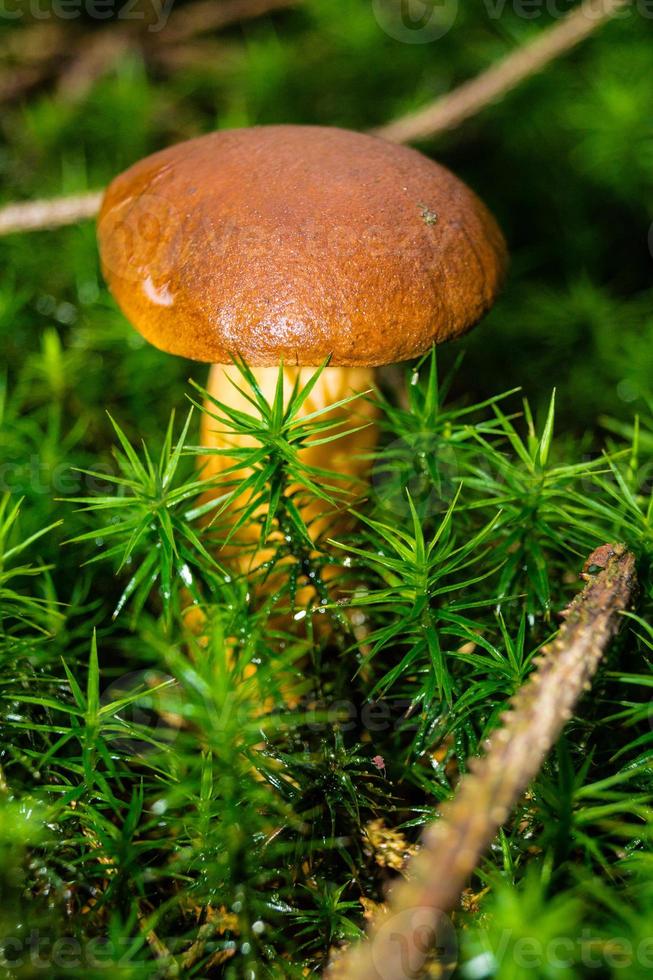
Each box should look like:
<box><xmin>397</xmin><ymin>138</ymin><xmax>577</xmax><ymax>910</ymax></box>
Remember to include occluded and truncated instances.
<box><xmin>0</xmin><ymin>0</ymin><xmax>653</xmax><ymax>980</ymax></box>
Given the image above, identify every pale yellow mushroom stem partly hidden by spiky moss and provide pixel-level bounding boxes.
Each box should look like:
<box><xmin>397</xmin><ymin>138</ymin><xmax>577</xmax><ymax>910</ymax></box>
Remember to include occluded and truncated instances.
<box><xmin>201</xmin><ymin>364</ymin><xmax>378</xmax><ymax>572</ymax></box>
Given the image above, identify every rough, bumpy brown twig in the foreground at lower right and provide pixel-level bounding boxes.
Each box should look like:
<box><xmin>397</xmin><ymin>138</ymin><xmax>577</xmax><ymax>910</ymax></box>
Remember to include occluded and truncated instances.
<box><xmin>328</xmin><ymin>545</ymin><xmax>637</xmax><ymax>980</ymax></box>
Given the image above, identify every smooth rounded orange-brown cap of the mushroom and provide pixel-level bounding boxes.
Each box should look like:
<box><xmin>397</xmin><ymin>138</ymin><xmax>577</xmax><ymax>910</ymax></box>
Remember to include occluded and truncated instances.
<box><xmin>99</xmin><ymin>126</ymin><xmax>506</xmax><ymax>366</ymax></box>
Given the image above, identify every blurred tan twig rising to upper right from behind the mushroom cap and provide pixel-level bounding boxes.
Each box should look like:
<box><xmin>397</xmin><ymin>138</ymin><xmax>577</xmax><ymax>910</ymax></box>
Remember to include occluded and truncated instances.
<box><xmin>375</xmin><ymin>0</ymin><xmax>630</xmax><ymax>143</ymax></box>
